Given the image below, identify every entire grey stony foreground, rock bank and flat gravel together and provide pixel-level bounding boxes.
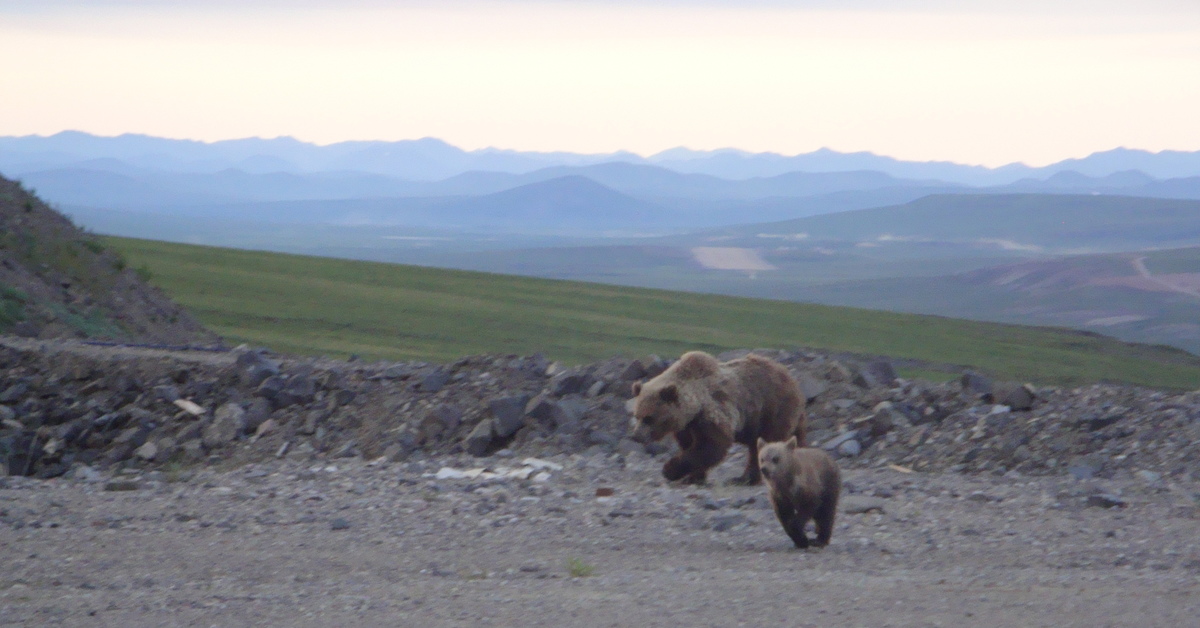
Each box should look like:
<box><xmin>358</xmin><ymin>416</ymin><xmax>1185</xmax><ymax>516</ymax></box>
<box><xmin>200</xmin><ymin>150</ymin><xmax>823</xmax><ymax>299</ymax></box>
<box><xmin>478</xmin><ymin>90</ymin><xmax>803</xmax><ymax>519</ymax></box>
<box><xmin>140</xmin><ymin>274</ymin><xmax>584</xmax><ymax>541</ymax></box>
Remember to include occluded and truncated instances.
<box><xmin>0</xmin><ymin>337</ymin><xmax>1200</xmax><ymax>627</ymax></box>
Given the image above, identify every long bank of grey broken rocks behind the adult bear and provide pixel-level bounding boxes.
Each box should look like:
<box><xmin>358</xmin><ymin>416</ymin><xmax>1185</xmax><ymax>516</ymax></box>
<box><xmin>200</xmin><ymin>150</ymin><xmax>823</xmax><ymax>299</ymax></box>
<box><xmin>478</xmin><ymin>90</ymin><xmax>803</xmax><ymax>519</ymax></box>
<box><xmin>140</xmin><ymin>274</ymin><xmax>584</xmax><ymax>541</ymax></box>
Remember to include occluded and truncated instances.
<box><xmin>0</xmin><ymin>342</ymin><xmax>1200</xmax><ymax>483</ymax></box>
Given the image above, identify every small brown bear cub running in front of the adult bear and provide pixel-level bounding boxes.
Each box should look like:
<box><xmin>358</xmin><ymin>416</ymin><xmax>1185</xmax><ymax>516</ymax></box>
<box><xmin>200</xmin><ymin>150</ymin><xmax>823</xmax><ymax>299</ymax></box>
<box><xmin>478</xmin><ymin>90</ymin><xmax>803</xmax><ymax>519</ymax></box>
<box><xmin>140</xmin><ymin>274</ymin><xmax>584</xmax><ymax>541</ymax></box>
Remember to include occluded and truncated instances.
<box><xmin>758</xmin><ymin>437</ymin><xmax>841</xmax><ymax>550</ymax></box>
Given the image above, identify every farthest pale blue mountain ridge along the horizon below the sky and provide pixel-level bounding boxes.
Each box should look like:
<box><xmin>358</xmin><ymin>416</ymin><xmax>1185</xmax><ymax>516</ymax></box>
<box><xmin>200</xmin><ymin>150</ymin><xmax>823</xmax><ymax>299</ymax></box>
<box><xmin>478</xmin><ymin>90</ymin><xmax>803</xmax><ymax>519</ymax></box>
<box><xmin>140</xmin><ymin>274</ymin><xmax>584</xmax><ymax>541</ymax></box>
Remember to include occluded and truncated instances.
<box><xmin>0</xmin><ymin>131</ymin><xmax>1200</xmax><ymax>186</ymax></box>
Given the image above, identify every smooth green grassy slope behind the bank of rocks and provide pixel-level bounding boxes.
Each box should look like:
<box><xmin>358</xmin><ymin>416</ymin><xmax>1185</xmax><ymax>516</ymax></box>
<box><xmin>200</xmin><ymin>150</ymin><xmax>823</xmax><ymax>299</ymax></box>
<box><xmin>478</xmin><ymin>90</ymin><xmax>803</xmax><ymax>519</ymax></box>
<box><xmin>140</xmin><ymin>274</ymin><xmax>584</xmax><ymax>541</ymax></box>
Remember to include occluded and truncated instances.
<box><xmin>109</xmin><ymin>238</ymin><xmax>1200</xmax><ymax>388</ymax></box>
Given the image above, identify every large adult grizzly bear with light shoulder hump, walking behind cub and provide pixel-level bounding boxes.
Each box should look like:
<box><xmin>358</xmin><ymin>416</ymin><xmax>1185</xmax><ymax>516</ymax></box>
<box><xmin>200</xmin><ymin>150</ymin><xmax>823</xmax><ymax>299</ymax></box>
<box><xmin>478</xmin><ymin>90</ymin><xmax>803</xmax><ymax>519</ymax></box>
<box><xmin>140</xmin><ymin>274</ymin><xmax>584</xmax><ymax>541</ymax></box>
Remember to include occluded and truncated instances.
<box><xmin>632</xmin><ymin>351</ymin><xmax>806</xmax><ymax>484</ymax></box>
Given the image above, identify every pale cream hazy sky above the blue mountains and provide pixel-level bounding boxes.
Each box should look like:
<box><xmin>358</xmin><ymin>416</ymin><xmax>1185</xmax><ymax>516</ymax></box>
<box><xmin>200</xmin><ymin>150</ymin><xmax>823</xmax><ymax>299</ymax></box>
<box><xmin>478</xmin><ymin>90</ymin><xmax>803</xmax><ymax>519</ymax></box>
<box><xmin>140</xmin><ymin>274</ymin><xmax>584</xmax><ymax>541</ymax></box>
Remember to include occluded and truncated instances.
<box><xmin>0</xmin><ymin>0</ymin><xmax>1200</xmax><ymax>166</ymax></box>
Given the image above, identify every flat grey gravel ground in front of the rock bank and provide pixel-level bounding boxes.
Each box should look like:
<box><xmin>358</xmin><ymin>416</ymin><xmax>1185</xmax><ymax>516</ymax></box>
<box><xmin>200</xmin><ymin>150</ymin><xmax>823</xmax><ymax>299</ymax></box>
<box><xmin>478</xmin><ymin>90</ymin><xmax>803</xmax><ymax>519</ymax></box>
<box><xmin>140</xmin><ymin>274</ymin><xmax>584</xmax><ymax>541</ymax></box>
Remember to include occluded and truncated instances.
<box><xmin>0</xmin><ymin>449</ymin><xmax>1200</xmax><ymax>627</ymax></box>
